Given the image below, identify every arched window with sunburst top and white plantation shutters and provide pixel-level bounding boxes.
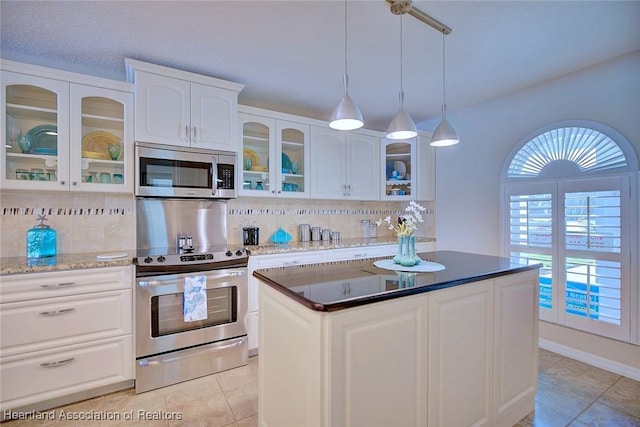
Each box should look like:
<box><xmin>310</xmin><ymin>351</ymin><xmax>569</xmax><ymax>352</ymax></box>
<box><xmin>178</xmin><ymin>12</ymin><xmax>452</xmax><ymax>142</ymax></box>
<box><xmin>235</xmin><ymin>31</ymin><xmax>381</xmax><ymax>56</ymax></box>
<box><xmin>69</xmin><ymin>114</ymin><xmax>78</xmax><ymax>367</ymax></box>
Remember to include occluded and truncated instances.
<box><xmin>501</xmin><ymin>122</ymin><xmax>638</xmax><ymax>341</ymax></box>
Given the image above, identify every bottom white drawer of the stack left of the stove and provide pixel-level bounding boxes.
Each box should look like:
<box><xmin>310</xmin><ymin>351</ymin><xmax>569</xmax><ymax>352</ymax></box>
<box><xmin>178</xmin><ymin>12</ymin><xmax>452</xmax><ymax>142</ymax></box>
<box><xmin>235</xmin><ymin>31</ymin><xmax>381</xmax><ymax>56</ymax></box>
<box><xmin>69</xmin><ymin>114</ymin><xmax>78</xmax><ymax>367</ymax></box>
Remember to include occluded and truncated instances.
<box><xmin>0</xmin><ymin>335</ymin><xmax>133</xmax><ymax>410</ymax></box>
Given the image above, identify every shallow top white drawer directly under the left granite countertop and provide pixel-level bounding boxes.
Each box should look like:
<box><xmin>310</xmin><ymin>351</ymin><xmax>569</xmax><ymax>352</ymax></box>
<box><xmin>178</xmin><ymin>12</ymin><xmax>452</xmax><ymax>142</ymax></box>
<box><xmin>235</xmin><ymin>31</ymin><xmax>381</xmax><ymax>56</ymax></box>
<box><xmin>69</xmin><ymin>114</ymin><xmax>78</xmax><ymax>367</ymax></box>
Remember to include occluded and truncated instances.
<box><xmin>0</xmin><ymin>266</ymin><xmax>133</xmax><ymax>303</ymax></box>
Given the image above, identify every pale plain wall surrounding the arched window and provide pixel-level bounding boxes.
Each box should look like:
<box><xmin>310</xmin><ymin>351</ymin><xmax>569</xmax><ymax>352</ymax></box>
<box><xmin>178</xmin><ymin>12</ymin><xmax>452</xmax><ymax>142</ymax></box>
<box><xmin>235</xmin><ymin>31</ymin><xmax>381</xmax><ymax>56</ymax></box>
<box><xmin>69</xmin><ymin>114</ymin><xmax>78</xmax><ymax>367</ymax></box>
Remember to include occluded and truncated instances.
<box><xmin>432</xmin><ymin>51</ymin><xmax>640</xmax><ymax>255</ymax></box>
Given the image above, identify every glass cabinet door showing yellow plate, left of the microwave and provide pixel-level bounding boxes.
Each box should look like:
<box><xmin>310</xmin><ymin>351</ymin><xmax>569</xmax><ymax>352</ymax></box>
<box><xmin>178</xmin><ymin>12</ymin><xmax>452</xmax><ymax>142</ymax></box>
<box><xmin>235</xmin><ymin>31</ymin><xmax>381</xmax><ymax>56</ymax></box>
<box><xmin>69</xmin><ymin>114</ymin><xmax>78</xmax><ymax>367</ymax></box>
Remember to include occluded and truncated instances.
<box><xmin>71</xmin><ymin>85</ymin><xmax>132</xmax><ymax>192</ymax></box>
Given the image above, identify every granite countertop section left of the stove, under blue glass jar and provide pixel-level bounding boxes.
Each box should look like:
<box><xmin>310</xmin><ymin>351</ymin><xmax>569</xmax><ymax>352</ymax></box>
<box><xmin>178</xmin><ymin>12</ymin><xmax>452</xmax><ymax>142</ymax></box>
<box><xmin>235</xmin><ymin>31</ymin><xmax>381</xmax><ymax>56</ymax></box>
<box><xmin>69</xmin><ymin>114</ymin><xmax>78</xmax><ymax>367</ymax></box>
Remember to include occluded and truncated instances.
<box><xmin>0</xmin><ymin>251</ymin><xmax>136</xmax><ymax>276</ymax></box>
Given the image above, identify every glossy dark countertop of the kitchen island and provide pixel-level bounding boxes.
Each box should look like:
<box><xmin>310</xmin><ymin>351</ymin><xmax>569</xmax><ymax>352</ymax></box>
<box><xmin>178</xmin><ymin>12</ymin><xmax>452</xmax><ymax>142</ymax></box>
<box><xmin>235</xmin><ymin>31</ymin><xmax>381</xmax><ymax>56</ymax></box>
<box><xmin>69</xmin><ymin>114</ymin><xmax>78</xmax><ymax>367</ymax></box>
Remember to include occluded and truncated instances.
<box><xmin>253</xmin><ymin>251</ymin><xmax>542</xmax><ymax>312</ymax></box>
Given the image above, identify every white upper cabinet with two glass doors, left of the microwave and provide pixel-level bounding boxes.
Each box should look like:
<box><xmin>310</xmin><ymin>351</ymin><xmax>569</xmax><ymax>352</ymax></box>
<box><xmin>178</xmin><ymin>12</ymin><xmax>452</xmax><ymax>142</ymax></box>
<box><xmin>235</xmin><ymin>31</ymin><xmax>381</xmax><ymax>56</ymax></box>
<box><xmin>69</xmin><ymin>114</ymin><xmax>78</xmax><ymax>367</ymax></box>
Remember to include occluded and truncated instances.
<box><xmin>0</xmin><ymin>61</ymin><xmax>133</xmax><ymax>193</ymax></box>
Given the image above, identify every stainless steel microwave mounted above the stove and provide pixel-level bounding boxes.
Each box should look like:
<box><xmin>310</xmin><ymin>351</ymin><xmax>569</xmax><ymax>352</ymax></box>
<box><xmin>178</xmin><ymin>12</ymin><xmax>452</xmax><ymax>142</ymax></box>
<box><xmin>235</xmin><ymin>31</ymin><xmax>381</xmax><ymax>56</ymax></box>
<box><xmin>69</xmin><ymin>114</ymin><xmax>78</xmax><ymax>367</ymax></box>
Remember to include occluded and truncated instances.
<box><xmin>135</xmin><ymin>142</ymin><xmax>238</xmax><ymax>199</ymax></box>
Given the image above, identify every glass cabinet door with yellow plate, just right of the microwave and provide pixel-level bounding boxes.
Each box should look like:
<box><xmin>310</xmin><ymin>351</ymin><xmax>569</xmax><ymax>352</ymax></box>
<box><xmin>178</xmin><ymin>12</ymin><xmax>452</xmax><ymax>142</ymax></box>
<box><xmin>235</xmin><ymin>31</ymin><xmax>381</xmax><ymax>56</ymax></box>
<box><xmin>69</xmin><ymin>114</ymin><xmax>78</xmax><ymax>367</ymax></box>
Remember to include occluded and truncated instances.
<box><xmin>239</xmin><ymin>114</ymin><xmax>276</xmax><ymax>196</ymax></box>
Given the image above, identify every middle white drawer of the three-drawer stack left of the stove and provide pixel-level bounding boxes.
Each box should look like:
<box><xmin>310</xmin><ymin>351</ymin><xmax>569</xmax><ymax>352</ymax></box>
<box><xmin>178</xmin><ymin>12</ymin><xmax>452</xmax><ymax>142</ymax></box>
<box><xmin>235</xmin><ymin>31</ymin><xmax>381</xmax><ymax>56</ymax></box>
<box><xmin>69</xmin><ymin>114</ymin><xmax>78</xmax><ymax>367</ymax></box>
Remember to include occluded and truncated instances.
<box><xmin>0</xmin><ymin>290</ymin><xmax>133</xmax><ymax>357</ymax></box>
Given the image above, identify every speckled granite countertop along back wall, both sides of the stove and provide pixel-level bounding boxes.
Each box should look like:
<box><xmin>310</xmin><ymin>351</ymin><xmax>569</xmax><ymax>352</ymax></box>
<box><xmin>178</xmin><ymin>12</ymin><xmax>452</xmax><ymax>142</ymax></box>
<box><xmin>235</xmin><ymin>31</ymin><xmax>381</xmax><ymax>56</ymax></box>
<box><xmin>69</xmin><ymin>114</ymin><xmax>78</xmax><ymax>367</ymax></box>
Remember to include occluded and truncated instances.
<box><xmin>0</xmin><ymin>237</ymin><xmax>436</xmax><ymax>276</ymax></box>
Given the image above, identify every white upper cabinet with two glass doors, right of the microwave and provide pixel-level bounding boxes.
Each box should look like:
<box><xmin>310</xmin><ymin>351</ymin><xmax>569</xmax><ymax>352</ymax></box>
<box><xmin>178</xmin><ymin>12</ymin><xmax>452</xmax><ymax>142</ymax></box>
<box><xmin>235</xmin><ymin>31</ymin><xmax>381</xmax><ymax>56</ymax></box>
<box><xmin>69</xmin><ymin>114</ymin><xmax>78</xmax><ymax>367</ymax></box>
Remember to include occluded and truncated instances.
<box><xmin>238</xmin><ymin>107</ymin><xmax>310</xmax><ymax>198</ymax></box>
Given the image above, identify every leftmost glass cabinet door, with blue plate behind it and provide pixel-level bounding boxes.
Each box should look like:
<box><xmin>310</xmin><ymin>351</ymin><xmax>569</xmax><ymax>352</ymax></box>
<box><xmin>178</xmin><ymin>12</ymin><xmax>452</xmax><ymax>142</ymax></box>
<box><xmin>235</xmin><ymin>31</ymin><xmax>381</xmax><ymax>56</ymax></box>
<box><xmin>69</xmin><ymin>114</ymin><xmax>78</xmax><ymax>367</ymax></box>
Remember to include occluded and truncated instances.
<box><xmin>2</xmin><ymin>72</ymin><xmax>69</xmax><ymax>190</ymax></box>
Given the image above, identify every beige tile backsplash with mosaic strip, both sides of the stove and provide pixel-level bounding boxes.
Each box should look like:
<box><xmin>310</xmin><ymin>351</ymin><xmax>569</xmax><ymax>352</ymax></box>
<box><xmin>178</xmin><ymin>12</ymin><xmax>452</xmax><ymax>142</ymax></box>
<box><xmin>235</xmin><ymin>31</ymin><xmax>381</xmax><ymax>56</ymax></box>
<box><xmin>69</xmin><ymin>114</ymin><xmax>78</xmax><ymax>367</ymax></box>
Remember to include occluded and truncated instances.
<box><xmin>0</xmin><ymin>190</ymin><xmax>435</xmax><ymax>257</ymax></box>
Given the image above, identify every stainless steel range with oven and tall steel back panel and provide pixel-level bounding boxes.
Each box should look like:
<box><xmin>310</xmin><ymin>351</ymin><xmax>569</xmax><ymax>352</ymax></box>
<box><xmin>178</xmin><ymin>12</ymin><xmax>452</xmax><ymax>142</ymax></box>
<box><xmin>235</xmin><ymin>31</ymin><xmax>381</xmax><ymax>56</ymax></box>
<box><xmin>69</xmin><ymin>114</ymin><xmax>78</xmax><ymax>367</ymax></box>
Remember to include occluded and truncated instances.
<box><xmin>135</xmin><ymin>198</ymin><xmax>249</xmax><ymax>393</ymax></box>
